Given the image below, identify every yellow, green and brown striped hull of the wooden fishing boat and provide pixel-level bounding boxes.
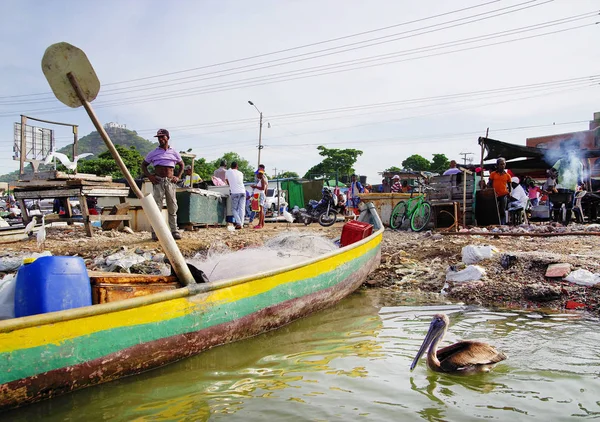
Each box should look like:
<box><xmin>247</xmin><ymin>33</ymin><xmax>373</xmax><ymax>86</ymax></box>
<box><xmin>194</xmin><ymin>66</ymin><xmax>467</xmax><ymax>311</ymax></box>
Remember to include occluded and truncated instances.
<box><xmin>0</xmin><ymin>206</ymin><xmax>383</xmax><ymax>409</ymax></box>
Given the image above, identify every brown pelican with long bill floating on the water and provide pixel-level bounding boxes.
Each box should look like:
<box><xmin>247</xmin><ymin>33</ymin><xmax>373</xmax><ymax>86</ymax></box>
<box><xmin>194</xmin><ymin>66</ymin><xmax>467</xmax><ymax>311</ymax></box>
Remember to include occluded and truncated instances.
<box><xmin>410</xmin><ymin>314</ymin><xmax>506</xmax><ymax>374</ymax></box>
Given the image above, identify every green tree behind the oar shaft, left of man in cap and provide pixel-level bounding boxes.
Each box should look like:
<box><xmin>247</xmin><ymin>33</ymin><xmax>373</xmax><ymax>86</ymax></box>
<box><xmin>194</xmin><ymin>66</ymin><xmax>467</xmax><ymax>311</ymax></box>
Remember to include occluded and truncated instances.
<box><xmin>77</xmin><ymin>145</ymin><xmax>144</xmax><ymax>179</ymax></box>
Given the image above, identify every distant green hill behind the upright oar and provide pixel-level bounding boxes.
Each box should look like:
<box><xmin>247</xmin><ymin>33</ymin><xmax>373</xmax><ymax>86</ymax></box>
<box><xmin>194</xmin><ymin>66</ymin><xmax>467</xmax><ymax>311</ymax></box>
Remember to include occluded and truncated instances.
<box><xmin>0</xmin><ymin>127</ymin><xmax>158</xmax><ymax>182</ymax></box>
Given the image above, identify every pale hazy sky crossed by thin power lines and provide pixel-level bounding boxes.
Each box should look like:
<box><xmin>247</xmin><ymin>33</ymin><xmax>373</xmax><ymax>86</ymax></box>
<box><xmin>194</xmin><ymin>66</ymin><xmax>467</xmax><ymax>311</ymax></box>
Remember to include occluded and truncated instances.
<box><xmin>0</xmin><ymin>0</ymin><xmax>600</xmax><ymax>184</ymax></box>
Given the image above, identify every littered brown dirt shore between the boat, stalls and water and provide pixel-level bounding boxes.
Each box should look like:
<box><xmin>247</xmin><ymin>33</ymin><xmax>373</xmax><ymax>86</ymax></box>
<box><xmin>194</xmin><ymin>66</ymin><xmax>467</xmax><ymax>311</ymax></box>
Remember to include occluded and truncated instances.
<box><xmin>1</xmin><ymin>219</ymin><xmax>600</xmax><ymax>314</ymax></box>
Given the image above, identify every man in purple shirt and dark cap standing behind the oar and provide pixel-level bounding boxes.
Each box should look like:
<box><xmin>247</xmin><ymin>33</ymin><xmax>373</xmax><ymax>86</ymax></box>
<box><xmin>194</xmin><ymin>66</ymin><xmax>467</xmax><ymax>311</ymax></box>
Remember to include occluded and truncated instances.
<box><xmin>142</xmin><ymin>129</ymin><xmax>183</xmax><ymax>240</ymax></box>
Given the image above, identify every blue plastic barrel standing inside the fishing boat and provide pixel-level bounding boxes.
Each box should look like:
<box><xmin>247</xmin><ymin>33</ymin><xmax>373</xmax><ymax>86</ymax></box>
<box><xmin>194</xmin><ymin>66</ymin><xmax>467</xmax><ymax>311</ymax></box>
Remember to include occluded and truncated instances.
<box><xmin>15</xmin><ymin>256</ymin><xmax>92</xmax><ymax>318</ymax></box>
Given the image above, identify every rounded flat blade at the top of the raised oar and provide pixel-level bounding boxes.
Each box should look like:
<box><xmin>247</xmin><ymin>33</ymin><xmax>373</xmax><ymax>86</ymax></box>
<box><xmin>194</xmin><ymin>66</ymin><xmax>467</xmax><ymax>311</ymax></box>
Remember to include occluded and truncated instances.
<box><xmin>42</xmin><ymin>42</ymin><xmax>100</xmax><ymax>108</ymax></box>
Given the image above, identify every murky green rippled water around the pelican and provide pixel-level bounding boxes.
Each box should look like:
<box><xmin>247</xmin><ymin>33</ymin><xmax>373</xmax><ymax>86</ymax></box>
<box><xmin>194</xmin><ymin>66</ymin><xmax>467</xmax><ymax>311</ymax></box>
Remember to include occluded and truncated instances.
<box><xmin>0</xmin><ymin>290</ymin><xmax>600</xmax><ymax>421</ymax></box>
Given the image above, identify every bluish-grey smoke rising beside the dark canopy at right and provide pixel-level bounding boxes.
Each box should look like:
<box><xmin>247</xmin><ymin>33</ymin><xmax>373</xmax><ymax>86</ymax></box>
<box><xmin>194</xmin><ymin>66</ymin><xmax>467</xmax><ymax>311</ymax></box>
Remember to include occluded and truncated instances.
<box><xmin>544</xmin><ymin>135</ymin><xmax>589</xmax><ymax>190</ymax></box>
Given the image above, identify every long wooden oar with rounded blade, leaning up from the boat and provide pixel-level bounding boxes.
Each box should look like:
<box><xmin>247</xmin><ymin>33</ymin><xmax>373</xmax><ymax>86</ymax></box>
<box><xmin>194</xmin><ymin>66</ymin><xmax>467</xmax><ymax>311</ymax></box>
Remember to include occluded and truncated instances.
<box><xmin>42</xmin><ymin>42</ymin><xmax>195</xmax><ymax>286</ymax></box>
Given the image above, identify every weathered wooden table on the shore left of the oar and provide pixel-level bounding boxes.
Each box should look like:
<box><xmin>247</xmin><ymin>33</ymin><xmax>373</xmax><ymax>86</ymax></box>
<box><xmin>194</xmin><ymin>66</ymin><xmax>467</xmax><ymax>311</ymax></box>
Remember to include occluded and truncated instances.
<box><xmin>14</xmin><ymin>179</ymin><xmax>131</xmax><ymax>237</ymax></box>
